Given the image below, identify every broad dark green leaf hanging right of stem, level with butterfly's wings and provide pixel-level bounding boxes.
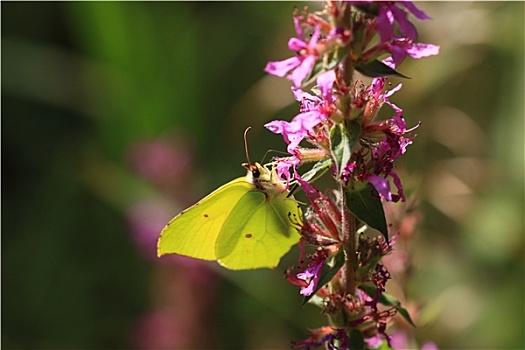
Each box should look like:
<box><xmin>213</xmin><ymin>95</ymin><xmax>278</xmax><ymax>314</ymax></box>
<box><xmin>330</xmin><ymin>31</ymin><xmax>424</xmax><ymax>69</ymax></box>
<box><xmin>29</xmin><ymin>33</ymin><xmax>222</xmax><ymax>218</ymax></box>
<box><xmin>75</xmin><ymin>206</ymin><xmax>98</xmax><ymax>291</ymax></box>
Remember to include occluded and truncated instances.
<box><xmin>346</xmin><ymin>182</ymin><xmax>388</xmax><ymax>242</ymax></box>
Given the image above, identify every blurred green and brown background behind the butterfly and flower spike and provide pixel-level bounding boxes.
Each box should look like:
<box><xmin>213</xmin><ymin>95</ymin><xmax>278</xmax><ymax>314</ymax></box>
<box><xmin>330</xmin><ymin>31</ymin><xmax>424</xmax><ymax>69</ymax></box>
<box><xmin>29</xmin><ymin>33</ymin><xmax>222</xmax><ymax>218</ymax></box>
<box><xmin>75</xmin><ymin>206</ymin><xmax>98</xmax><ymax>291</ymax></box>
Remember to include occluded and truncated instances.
<box><xmin>1</xmin><ymin>2</ymin><xmax>525</xmax><ymax>349</ymax></box>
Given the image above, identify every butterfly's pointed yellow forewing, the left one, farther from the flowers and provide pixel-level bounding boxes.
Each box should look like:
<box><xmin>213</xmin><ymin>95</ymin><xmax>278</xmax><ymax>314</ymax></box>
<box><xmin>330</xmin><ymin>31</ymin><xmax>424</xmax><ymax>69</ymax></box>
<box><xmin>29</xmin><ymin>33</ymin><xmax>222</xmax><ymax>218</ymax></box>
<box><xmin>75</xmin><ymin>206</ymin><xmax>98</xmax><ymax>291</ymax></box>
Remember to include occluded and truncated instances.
<box><xmin>157</xmin><ymin>177</ymin><xmax>254</xmax><ymax>260</ymax></box>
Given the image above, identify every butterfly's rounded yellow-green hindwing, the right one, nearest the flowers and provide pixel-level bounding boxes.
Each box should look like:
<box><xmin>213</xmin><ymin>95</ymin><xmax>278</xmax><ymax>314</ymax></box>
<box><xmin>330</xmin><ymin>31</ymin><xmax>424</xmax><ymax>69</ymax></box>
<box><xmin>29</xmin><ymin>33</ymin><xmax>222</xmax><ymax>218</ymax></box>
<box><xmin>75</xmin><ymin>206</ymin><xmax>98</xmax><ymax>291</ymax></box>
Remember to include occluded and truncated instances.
<box><xmin>216</xmin><ymin>190</ymin><xmax>301</xmax><ymax>270</ymax></box>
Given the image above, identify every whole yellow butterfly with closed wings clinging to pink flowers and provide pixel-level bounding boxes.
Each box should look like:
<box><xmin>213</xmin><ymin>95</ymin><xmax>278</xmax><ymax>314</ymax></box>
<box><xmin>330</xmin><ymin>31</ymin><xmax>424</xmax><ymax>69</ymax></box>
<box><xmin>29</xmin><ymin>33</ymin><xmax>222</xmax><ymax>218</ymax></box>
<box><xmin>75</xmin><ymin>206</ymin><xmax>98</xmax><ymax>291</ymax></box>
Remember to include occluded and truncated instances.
<box><xmin>157</xmin><ymin>130</ymin><xmax>302</xmax><ymax>270</ymax></box>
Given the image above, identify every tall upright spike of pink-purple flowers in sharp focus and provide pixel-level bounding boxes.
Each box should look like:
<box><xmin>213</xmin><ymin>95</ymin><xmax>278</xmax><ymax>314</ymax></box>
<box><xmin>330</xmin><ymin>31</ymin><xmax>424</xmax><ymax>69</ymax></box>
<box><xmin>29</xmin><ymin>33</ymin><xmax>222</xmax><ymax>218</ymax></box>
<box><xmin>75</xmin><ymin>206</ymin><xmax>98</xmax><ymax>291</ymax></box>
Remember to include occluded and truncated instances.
<box><xmin>265</xmin><ymin>1</ymin><xmax>439</xmax><ymax>349</ymax></box>
